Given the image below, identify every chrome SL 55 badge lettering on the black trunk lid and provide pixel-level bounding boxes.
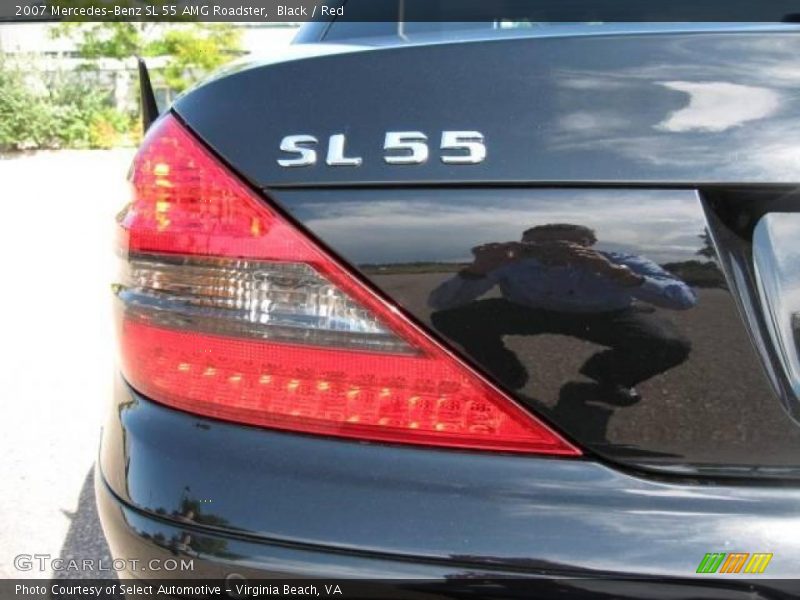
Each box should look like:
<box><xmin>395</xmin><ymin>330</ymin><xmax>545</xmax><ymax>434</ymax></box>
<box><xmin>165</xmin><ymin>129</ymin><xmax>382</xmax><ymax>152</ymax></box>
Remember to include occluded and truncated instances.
<box><xmin>278</xmin><ymin>131</ymin><xmax>486</xmax><ymax>167</ymax></box>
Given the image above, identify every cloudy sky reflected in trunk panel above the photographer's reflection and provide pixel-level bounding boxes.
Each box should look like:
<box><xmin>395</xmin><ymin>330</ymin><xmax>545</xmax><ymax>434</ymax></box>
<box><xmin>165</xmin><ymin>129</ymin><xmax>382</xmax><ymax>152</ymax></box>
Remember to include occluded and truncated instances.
<box><xmin>292</xmin><ymin>189</ymin><xmax>705</xmax><ymax>264</ymax></box>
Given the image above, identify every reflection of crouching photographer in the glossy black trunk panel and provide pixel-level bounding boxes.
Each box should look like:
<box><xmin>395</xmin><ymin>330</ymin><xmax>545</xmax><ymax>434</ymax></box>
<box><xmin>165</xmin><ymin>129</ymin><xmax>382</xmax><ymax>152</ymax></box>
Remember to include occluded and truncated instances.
<box><xmin>428</xmin><ymin>224</ymin><xmax>697</xmax><ymax>403</ymax></box>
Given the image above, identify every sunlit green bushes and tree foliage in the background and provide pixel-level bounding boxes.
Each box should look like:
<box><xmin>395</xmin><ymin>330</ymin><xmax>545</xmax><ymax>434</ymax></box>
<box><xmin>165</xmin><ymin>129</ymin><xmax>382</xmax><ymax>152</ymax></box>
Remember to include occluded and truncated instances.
<box><xmin>0</xmin><ymin>20</ymin><xmax>241</xmax><ymax>150</ymax></box>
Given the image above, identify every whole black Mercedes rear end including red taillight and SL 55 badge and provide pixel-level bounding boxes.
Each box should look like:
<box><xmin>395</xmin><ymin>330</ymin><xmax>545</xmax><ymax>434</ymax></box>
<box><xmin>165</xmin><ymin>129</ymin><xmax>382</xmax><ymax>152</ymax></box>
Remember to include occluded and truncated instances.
<box><xmin>96</xmin><ymin>0</ymin><xmax>800</xmax><ymax>599</ymax></box>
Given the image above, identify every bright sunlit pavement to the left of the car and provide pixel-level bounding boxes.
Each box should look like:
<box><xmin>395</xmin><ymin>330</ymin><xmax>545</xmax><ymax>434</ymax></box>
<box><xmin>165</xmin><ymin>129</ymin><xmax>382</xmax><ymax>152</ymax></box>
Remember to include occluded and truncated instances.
<box><xmin>0</xmin><ymin>151</ymin><xmax>131</xmax><ymax>577</ymax></box>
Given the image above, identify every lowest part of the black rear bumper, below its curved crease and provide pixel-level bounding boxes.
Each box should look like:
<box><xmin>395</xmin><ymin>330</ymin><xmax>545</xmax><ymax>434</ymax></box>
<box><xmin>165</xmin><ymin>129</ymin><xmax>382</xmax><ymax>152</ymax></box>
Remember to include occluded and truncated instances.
<box><xmin>95</xmin><ymin>477</ymin><xmax>797</xmax><ymax>600</ymax></box>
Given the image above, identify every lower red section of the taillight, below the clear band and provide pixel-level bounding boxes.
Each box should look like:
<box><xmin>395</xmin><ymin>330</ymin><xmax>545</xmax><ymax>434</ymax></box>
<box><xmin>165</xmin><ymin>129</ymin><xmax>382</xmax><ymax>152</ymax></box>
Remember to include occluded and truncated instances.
<box><xmin>123</xmin><ymin>321</ymin><xmax>570</xmax><ymax>454</ymax></box>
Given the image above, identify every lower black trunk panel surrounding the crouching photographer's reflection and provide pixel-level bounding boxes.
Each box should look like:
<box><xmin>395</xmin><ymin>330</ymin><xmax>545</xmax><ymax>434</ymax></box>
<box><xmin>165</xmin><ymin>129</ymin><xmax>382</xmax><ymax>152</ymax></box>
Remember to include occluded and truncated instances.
<box><xmin>273</xmin><ymin>188</ymin><xmax>800</xmax><ymax>477</ymax></box>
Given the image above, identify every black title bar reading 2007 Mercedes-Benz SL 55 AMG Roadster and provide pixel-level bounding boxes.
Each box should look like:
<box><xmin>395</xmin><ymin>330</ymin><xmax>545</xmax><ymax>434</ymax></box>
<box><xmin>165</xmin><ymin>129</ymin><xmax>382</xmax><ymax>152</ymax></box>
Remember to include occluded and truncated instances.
<box><xmin>0</xmin><ymin>0</ymin><xmax>800</xmax><ymax>26</ymax></box>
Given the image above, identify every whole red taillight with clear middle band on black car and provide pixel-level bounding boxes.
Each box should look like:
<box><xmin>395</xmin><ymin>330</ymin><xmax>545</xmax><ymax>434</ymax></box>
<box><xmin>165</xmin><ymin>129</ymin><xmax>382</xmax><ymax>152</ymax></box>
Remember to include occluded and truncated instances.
<box><xmin>115</xmin><ymin>116</ymin><xmax>580</xmax><ymax>456</ymax></box>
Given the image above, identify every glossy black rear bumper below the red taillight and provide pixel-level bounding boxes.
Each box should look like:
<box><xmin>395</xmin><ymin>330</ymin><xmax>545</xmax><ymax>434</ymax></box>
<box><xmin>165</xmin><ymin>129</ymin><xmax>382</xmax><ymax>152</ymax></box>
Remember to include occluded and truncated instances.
<box><xmin>97</xmin><ymin>384</ymin><xmax>800</xmax><ymax>584</ymax></box>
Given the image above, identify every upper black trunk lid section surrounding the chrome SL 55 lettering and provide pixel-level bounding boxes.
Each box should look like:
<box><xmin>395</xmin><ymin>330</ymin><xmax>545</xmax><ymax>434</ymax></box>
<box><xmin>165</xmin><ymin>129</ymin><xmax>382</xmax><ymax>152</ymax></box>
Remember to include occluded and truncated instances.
<box><xmin>175</xmin><ymin>25</ymin><xmax>800</xmax><ymax>186</ymax></box>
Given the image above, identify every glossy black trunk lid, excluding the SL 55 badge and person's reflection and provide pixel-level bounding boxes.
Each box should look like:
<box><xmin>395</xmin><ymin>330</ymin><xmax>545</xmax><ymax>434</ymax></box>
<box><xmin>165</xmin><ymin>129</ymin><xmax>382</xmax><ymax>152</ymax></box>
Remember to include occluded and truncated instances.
<box><xmin>175</xmin><ymin>31</ymin><xmax>800</xmax><ymax>477</ymax></box>
